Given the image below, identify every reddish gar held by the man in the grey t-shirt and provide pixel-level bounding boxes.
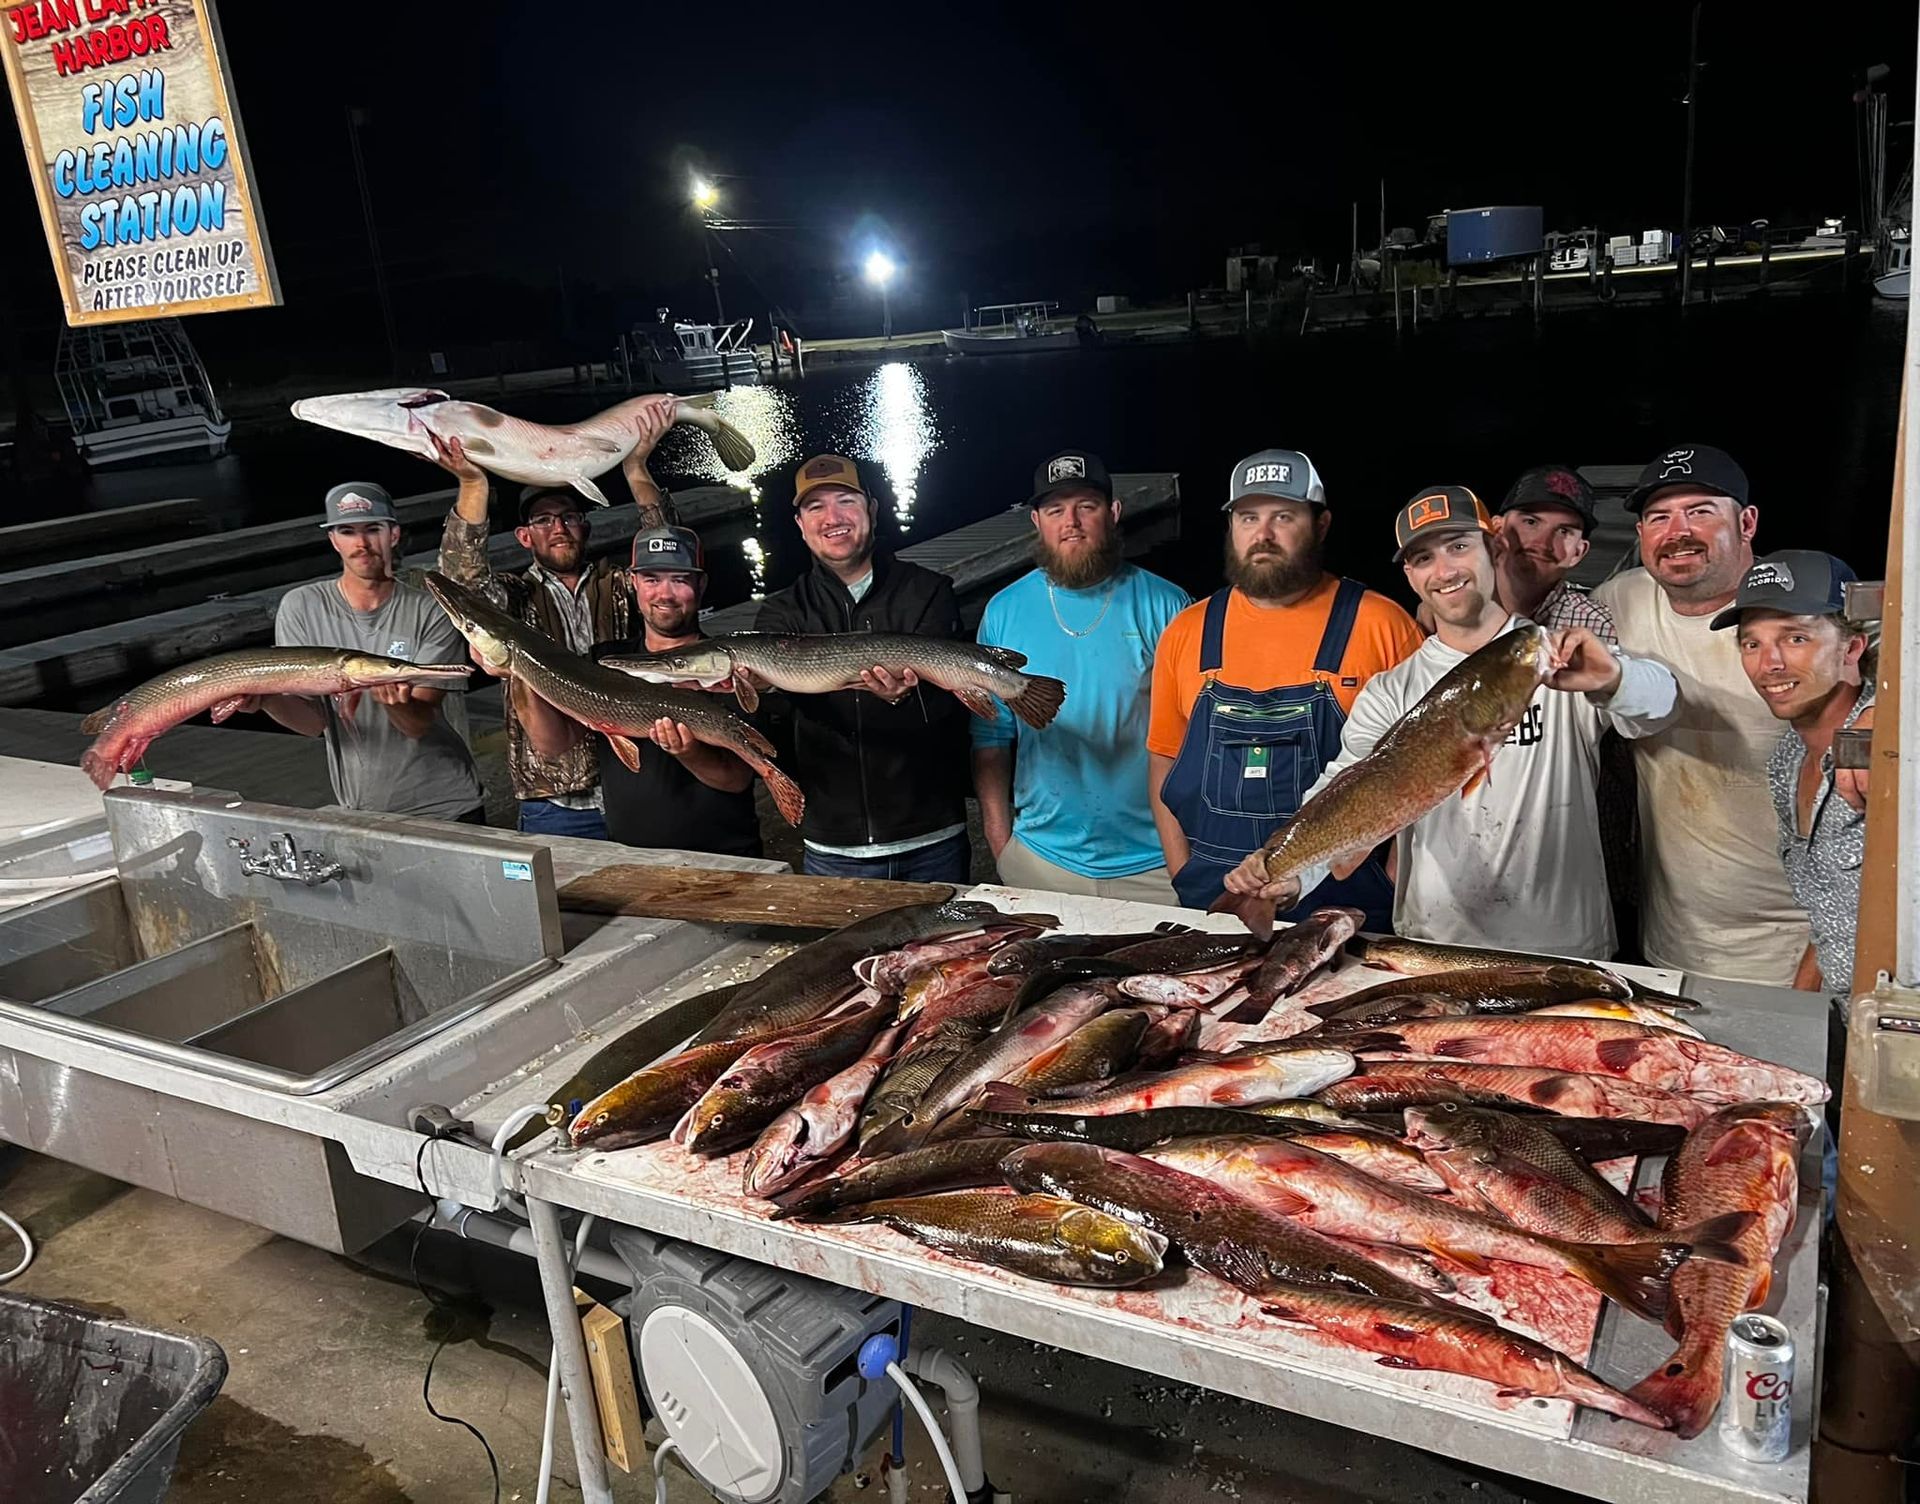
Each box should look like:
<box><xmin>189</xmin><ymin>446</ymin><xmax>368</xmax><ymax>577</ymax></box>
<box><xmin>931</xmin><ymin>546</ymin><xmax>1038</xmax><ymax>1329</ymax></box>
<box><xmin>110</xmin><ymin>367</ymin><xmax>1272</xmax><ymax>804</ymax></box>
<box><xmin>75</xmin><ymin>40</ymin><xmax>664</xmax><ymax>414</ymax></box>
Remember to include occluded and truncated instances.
<box><xmin>81</xmin><ymin>647</ymin><xmax>472</xmax><ymax>788</ymax></box>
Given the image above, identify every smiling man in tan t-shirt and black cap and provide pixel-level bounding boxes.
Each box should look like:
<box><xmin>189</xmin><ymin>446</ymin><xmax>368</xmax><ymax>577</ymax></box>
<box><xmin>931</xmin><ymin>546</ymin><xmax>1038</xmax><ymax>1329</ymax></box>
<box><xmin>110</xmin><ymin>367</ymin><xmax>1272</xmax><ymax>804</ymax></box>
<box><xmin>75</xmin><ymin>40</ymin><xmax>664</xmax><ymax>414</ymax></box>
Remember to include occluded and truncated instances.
<box><xmin>1594</xmin><ymin>446</ymin><xmax>1809</xmax><ymax>987</ymax></box>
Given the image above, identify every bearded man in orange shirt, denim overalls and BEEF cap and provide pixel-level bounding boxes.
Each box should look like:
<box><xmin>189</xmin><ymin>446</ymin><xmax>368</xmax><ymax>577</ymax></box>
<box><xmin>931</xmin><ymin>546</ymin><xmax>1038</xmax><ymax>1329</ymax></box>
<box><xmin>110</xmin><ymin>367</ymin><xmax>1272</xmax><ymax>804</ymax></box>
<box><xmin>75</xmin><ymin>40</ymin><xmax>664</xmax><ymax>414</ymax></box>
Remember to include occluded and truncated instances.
<box><xmin>1146</xmin><ymin>449</ymin><xmax>1423</xmax><ymax>918</ymax></box>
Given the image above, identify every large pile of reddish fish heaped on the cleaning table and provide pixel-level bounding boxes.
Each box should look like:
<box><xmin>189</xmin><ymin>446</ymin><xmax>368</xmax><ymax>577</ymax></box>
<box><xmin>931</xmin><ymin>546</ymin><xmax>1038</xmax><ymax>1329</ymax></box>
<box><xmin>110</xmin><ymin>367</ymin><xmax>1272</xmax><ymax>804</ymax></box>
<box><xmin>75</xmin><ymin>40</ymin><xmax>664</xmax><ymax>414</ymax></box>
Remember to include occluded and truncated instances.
<box><xmin>547</xmin><ymin>901</ymin><xmax>1828</xmax><ymax>1437</ymax></box>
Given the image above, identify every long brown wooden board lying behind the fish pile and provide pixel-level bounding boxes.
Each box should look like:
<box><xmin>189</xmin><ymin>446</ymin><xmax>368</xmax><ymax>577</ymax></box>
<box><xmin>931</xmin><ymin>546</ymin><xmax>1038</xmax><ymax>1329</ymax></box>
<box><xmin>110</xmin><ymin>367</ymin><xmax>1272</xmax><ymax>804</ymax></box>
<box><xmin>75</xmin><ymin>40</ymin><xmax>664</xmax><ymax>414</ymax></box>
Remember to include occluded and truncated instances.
<box><xmin>559</xmin><ymin>866</ymin><xmax>954</xmax><ymax>930</ymax></box>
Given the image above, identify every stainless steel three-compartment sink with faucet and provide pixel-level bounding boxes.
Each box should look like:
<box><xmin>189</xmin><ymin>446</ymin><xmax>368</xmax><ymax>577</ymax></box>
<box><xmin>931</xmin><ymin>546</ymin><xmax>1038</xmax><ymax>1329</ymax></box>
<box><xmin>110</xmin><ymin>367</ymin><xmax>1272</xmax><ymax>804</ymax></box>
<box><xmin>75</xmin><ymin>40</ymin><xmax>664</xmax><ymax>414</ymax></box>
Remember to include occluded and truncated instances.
<box><xmin>0</xmin><ymin>791</ymin><xmax>561</xmax><ymax>1095</ymax></box>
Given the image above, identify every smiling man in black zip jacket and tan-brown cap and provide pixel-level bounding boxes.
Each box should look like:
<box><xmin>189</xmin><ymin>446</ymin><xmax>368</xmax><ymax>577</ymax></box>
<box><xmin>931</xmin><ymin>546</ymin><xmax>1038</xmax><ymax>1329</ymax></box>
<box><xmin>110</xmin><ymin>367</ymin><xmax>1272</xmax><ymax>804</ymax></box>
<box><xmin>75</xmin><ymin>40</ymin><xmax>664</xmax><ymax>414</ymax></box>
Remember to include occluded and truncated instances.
<box><xmin>756</xmin><ymin>455</ymin><xmax>973</xmax><ymax>884</ymax></box>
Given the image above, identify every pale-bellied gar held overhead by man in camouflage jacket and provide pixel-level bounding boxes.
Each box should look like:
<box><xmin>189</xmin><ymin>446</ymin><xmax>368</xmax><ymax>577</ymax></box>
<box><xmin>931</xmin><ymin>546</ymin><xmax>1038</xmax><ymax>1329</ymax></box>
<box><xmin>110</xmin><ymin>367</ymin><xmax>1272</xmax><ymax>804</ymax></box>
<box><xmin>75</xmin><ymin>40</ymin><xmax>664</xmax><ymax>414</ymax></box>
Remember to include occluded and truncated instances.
<box><xmin>294</xmin><ymin>386</ymin><xmax>755</xmax><ymax>507</ymax></box>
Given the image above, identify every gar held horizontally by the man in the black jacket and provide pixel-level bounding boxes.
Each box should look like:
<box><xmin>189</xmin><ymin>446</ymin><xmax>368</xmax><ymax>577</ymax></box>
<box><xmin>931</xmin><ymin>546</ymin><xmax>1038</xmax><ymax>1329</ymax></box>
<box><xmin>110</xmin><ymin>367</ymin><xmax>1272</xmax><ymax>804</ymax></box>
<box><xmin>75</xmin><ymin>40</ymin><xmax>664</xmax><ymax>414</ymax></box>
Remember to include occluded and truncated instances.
<box><xmin>605</xmin><ymin>632</ymin><xmax>1068</xmax><ymax>728</ymax></box>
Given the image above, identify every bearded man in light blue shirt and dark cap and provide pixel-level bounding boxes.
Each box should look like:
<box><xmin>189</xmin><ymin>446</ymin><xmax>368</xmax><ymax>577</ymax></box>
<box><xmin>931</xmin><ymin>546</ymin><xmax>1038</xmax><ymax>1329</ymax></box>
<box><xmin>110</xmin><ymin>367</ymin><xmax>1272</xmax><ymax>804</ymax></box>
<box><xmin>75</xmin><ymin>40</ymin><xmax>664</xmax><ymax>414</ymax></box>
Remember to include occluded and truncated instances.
<box><xmin>973</xmin><ymin>449</ymin><xmax>1188</xmax><ymax>907</ymax></box>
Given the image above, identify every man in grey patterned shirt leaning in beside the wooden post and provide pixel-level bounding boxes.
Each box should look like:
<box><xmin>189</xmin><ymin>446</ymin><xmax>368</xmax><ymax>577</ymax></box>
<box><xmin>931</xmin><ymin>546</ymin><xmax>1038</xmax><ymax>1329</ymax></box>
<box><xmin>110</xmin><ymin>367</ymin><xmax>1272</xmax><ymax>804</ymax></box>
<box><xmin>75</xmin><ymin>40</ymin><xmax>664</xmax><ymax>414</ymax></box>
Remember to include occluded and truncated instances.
<box><xmin>1713</xmin><ymin>549</ymin><xmax>1874</xmax><ymax>995</ymax></box>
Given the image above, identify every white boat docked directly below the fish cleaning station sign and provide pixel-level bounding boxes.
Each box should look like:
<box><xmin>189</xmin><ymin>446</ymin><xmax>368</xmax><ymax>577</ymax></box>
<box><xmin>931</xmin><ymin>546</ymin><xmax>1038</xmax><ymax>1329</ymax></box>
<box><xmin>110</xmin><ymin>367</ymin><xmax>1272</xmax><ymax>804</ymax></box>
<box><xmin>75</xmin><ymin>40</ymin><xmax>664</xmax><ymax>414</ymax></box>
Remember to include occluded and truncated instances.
<box><xmin>54</xmin><ymin>319</ymin><xmax>232</xmax><ymax>465</ymax></box>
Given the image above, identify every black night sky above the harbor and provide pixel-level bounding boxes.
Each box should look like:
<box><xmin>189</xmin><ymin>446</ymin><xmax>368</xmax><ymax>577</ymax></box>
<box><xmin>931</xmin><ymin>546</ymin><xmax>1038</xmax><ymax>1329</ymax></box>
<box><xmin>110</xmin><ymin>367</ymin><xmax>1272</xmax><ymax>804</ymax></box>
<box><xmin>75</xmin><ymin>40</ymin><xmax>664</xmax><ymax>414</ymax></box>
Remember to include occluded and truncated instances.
<box><xmin>0</xmin><ymin>0</ymin><xmax>1914</xmax><ymax>363</ymax></box>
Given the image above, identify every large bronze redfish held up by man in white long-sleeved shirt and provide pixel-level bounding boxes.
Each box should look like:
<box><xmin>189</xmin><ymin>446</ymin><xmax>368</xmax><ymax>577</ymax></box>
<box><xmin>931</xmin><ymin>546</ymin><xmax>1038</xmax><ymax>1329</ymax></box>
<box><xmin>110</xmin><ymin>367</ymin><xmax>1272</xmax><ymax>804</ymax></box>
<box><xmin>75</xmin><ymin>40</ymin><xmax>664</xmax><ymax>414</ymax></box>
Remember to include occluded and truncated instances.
<box><xmin>1213</xmin><ymin>622</ymin><xmax>1557</xmax><ymax>937</ymax></box>
